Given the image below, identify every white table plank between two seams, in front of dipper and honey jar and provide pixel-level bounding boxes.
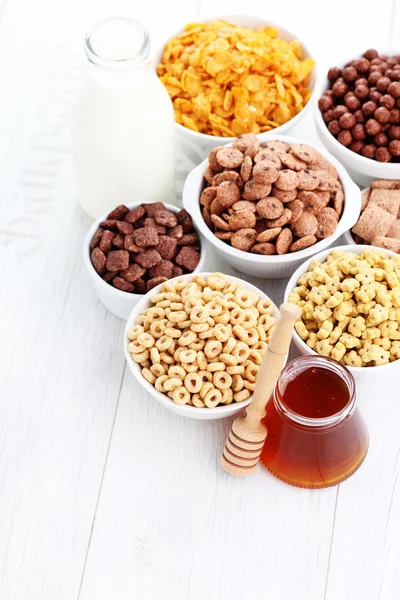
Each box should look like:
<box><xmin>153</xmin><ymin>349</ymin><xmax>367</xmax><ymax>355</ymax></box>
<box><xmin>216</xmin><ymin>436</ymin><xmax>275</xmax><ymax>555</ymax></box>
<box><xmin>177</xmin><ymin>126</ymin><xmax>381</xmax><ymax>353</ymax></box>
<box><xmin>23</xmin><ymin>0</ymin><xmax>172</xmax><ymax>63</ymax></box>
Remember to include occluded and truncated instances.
<box><xmin>80</xmin><ymin>346</ymin><xmax>336</xmax><ymax>600</ymax></box>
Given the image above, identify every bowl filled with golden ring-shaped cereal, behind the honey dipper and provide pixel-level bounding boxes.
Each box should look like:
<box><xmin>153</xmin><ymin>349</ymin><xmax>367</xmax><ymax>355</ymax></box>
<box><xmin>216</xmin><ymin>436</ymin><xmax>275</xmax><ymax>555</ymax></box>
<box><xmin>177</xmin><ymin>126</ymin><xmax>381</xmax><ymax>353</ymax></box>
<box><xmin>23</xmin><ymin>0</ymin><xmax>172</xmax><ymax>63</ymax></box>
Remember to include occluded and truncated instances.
<box><xmin>124</xmin><ymin>273</ymin><xmax>279</xmax><ymax>420</ymax></box>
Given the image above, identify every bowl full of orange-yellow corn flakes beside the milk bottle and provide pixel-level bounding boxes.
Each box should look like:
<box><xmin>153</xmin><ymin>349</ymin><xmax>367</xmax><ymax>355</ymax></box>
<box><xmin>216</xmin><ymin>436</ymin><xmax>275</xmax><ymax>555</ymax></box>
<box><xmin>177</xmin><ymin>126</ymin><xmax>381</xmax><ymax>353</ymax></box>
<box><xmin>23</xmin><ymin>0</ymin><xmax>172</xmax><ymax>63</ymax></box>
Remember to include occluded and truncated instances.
<box><xmin>155</xmin><ymin>15</ymin><xmax>316</xmax><ymax>148</ymax></box>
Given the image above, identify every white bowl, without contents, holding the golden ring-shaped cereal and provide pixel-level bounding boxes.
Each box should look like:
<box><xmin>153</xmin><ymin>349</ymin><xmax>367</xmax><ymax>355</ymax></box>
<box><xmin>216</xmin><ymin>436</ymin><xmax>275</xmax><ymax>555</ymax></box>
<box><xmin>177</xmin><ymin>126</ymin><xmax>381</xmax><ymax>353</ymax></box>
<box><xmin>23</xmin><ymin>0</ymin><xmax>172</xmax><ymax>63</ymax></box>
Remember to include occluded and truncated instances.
<box><xmin>124</xmin><ymin>273</ymin><xmax>280</xmax><ymax>420</ymax></box>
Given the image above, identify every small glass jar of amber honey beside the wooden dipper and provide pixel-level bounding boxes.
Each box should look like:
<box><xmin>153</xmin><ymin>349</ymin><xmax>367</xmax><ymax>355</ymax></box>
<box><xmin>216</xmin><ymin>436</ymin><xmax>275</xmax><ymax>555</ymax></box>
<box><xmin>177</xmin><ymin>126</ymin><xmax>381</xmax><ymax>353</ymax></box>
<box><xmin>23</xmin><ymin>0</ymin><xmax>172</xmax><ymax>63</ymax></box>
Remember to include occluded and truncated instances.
<box><xmin>261</xmin><ymin>356</ymin><xmax>369</xmax><ymax>488</ymax></box>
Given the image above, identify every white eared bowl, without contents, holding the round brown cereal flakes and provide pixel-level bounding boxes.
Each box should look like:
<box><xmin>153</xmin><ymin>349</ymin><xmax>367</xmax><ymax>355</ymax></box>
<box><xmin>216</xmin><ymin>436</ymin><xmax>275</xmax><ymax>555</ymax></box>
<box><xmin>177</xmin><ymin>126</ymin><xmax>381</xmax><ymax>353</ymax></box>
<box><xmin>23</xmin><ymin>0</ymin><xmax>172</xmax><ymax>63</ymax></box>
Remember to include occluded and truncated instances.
<box><xmin>182</xmin><ymin>135</ymin><xmax>361</xmax><ymax>279</ymax></box>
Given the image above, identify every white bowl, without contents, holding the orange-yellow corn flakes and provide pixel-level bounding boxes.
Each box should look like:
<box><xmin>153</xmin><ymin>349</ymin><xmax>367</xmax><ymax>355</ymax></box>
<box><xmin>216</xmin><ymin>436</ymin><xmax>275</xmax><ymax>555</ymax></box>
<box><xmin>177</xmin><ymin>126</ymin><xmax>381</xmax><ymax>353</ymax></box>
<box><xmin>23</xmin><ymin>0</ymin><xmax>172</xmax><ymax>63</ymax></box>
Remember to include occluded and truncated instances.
<box><xmin>153</xmin><ymin>15</ymin><xmax>317</xmax><ymax>150</ymax></box>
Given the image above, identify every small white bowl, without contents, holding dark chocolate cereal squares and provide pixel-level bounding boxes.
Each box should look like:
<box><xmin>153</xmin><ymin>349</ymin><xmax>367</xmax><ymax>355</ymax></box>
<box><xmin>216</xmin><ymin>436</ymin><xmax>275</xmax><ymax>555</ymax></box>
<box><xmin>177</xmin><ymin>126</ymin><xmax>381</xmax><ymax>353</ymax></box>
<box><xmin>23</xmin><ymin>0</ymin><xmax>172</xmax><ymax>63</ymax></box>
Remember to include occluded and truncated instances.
<box><xmin>83</xmin><ymin>202</ymin><xmax>206</xmax><ymax>319</ymax></box>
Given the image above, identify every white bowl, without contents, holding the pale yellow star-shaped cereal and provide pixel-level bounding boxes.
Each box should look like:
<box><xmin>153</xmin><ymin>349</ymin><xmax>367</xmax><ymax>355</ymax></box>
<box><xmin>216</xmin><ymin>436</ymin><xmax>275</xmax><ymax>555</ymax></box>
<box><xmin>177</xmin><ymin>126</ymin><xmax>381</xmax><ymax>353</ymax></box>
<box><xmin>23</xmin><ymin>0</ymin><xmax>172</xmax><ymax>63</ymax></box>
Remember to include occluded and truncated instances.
<box><xmin>284</xmin><ymin>244</ymin><xmax>400</xmax><ymax>383</ymax></box>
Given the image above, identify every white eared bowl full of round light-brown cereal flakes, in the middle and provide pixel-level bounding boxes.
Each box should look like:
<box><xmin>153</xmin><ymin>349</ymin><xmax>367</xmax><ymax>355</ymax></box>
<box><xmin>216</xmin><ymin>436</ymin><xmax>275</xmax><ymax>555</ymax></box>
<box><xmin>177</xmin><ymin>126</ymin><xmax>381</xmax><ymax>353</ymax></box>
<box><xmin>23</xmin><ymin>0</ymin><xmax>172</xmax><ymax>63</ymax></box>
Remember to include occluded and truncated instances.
<box><xmin>183</xmin><ymin>134</ymin><xmax>361</xmax><ymax>278</ymax></box>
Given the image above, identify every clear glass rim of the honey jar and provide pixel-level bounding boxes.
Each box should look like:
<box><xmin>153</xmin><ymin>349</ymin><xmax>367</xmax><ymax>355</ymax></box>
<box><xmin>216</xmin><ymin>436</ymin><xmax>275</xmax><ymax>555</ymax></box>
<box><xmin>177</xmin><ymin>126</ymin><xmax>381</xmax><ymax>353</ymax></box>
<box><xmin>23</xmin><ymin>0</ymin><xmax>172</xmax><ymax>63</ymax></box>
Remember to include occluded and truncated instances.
<box><xmin>273</xmin><ymin>356</ymin><xmax>356</xmax><ymax>429</ymax></box>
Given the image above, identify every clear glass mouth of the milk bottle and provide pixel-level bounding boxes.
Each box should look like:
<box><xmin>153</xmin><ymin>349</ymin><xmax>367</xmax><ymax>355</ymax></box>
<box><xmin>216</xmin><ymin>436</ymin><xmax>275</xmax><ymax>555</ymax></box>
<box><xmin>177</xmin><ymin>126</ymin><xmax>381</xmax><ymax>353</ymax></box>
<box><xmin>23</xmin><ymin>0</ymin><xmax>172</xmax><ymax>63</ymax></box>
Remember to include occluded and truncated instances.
<box><xmin>85</xmin><ymin>17</ymin><xmax>150</xmax><ymax>70</ymax></box>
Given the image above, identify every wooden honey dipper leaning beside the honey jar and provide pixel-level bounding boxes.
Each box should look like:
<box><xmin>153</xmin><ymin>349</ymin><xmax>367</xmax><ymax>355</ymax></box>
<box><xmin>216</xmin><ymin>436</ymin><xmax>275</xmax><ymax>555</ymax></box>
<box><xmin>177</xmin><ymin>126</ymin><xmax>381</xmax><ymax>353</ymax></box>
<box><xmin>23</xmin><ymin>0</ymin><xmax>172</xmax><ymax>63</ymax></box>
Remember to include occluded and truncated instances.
<box><xmin>221</xmin><ymin>302</ymin><xmax>301</xmax><ymax>475</ymax></box>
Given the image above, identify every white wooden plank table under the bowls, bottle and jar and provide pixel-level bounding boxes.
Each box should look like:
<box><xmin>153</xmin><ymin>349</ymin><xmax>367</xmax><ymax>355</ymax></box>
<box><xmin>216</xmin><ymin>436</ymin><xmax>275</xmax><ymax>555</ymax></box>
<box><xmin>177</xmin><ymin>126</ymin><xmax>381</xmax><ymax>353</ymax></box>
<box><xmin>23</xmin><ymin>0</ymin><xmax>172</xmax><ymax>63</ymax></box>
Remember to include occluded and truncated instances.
<box><xmin>0</xmin><ymin>0</ymin><xmax>400</xmax><ymax>600</ymax></box>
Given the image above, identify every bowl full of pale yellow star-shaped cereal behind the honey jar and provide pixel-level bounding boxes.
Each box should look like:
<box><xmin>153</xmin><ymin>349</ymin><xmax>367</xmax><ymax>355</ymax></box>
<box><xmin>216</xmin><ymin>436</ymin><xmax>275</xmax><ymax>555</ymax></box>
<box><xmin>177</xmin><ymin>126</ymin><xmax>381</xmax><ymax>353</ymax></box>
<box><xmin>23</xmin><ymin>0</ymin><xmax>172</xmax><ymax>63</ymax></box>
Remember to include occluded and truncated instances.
<box><xmin>284</xmin><ymin>244</ymin><xmax>400</xmax><ymax>382</ymax></box>
